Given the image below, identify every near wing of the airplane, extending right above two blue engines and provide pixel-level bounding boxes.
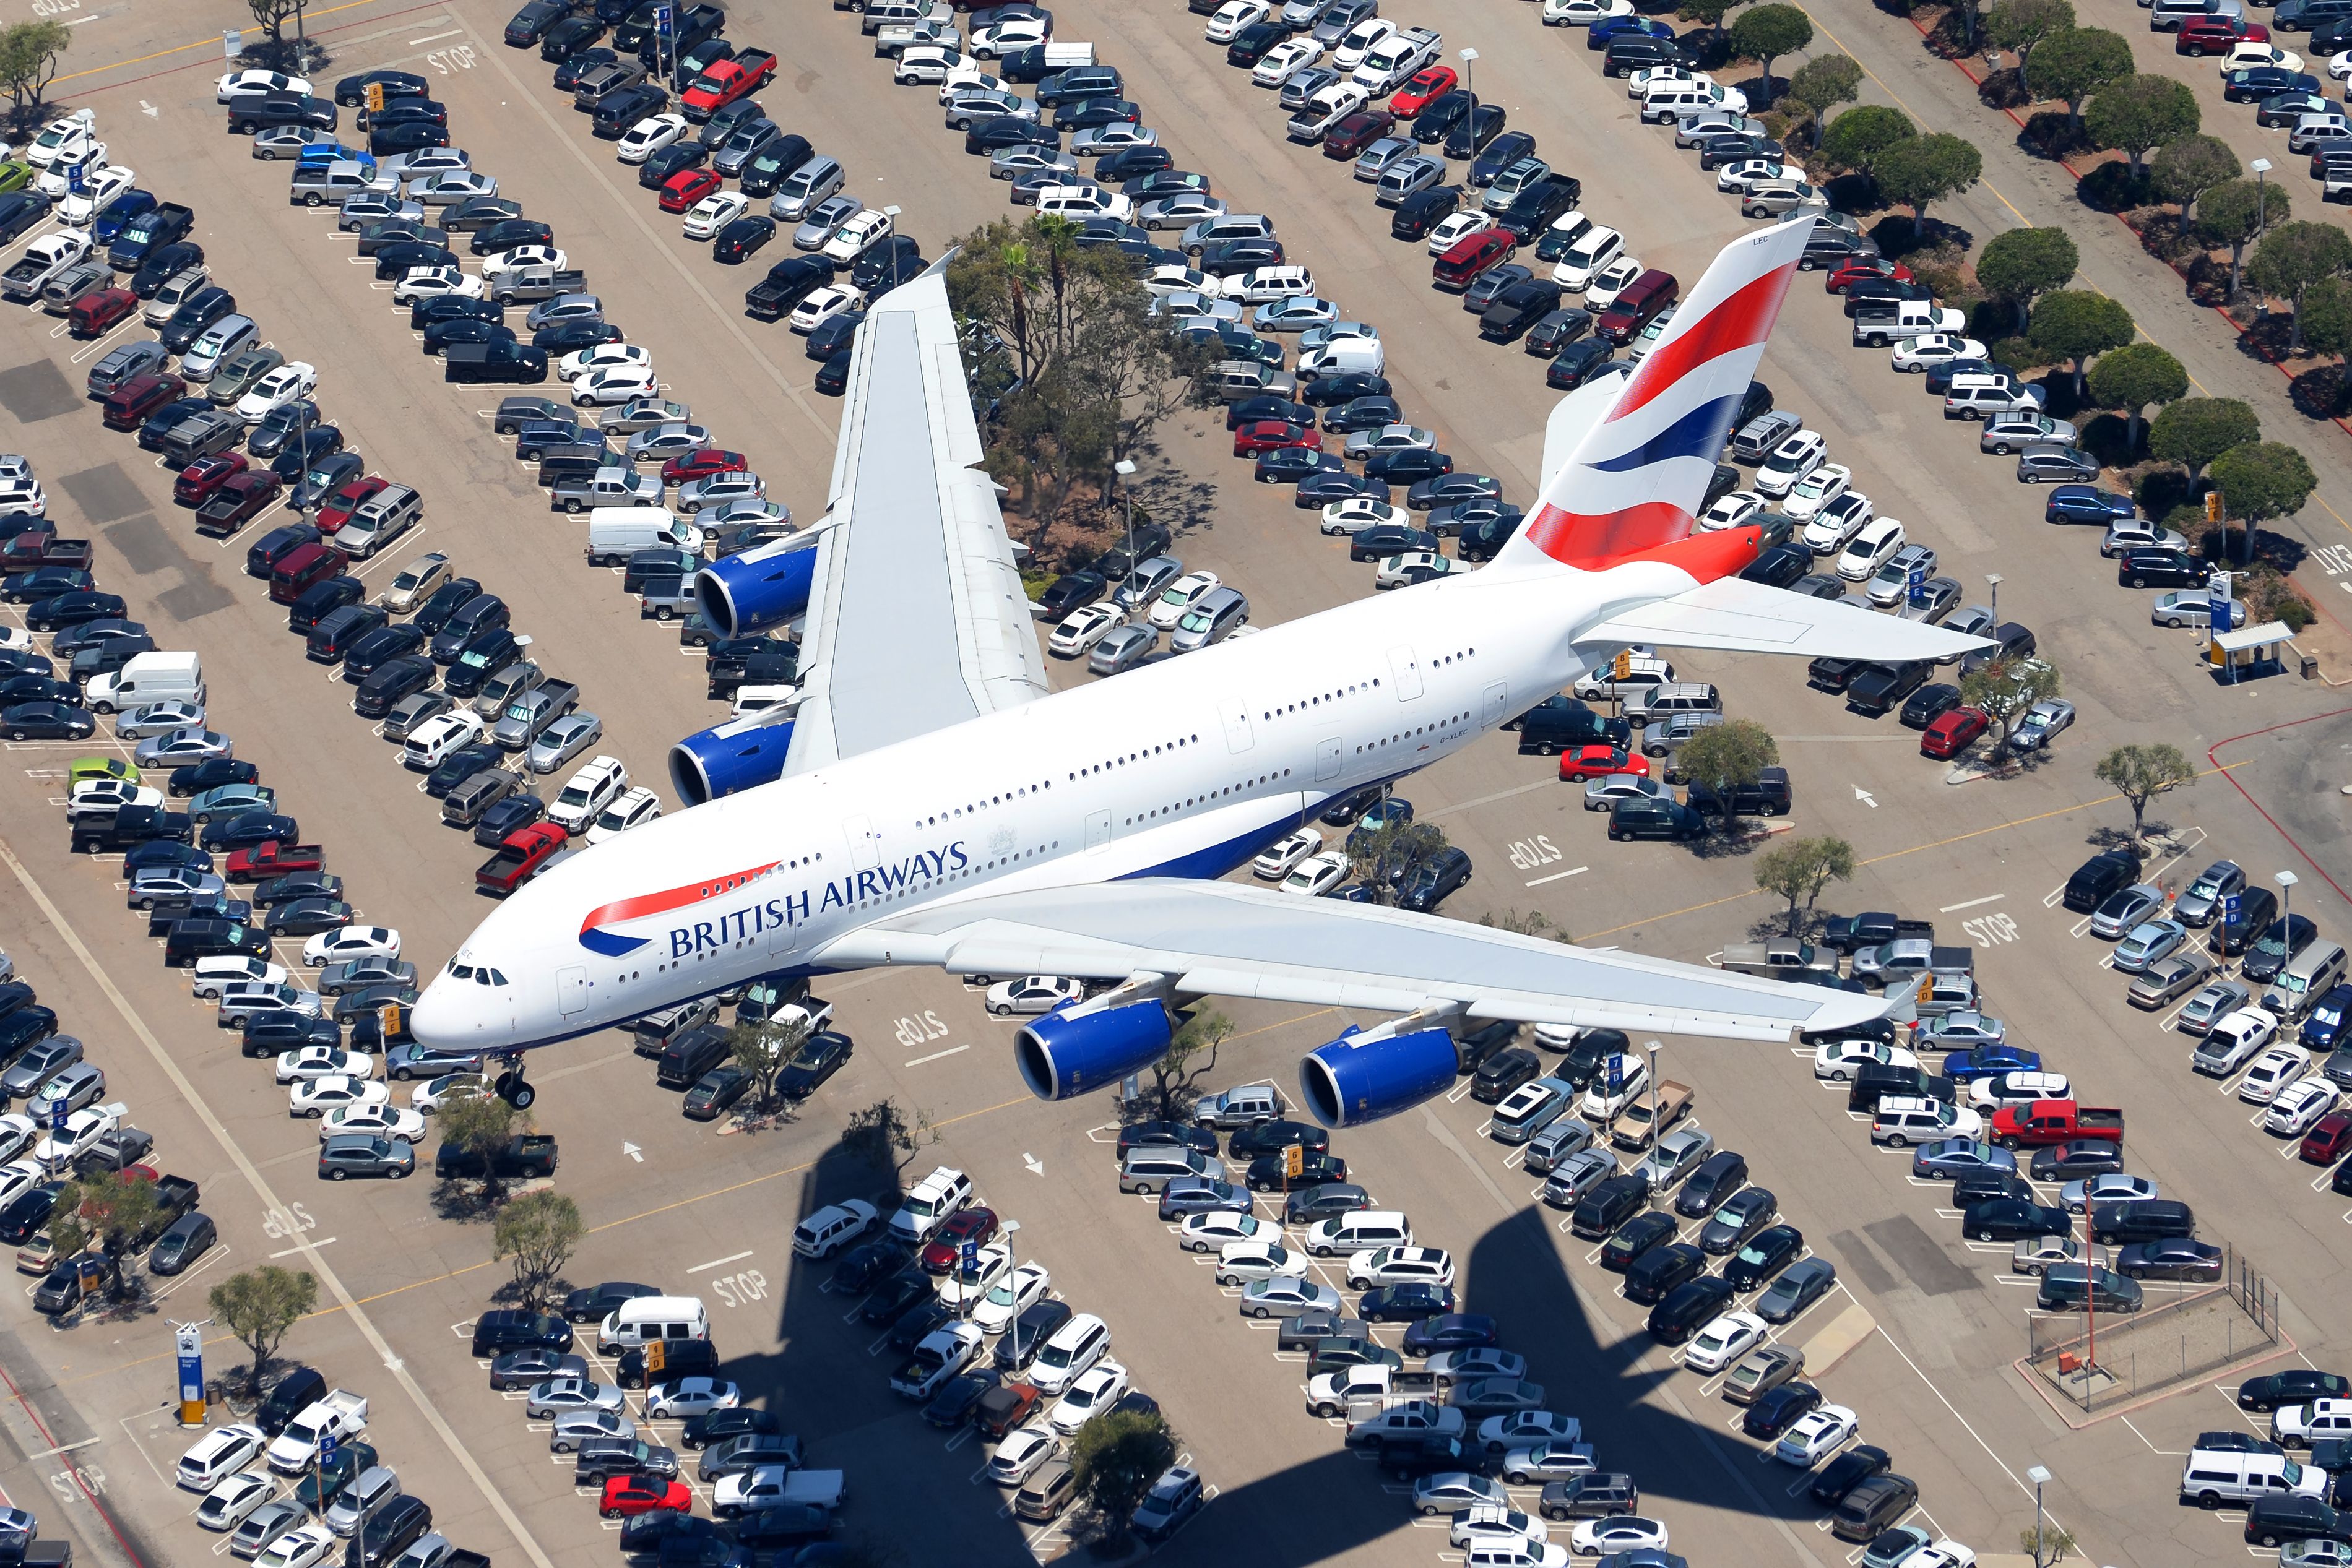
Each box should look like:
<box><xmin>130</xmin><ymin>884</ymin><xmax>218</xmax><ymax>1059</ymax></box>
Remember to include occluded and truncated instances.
<box><xmin>814</xmin><ymin>879</ymin><xmax>1887</xmax><ymax>1039</ymax></box>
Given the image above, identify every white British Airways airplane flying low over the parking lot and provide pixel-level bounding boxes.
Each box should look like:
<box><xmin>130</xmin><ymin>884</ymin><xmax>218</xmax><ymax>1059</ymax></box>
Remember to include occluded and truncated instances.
<box><xmin>412</xmin><ymin>217</ymin><xmax>1985</xmax><ymax>1126</ymax></box>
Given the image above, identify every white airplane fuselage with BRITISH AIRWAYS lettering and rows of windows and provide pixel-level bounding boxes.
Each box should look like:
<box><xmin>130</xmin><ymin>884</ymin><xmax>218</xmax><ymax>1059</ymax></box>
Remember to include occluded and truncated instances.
<box><xmin>412</xmin><ymin>564</ymin><xmax>1691</xmax><ymax>1051</ymax></box>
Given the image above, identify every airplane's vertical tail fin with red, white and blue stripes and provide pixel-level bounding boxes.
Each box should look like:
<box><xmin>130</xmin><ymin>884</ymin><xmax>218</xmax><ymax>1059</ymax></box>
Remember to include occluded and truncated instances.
<box><xmin>1498</xmin><ymin>217</ymin><xmax>1814</xmax><ymax>580</ymax></box>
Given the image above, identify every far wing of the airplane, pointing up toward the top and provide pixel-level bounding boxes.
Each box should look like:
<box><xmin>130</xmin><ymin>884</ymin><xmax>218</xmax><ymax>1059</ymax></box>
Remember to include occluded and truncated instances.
<box><xmin>785</xmin><ymin>263</ymin><xmax>1047</xmax><ymax>773</ymax></box>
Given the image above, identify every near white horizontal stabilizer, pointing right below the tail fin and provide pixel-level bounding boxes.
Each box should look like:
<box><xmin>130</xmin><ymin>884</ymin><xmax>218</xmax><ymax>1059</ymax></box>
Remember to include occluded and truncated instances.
<box><xmin>1578</xmin><ymin>579</ymin><xmax>1992</xmax><ymax>663</ymax></box>
